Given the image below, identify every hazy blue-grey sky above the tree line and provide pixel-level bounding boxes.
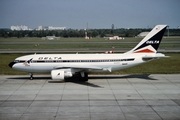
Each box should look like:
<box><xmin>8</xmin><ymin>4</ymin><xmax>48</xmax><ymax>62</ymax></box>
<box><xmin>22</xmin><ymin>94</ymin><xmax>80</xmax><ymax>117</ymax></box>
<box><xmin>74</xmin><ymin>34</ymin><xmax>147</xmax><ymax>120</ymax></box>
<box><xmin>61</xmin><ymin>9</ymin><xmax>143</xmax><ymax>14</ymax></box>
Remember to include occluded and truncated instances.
<box><xmin>0</xmin><ymin>0</ymin><xmax>180</xmax><ymax>29</ymax></box>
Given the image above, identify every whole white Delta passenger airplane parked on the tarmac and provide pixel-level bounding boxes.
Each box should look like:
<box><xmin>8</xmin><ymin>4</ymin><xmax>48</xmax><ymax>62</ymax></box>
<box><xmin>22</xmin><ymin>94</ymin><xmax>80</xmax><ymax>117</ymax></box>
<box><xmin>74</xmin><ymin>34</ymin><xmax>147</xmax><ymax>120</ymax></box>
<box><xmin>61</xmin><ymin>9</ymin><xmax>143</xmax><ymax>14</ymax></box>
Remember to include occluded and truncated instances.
<box><xmin>9</xmin><ymin>25</ymin><xmax>167</xmax><ymax>82</ymax></box>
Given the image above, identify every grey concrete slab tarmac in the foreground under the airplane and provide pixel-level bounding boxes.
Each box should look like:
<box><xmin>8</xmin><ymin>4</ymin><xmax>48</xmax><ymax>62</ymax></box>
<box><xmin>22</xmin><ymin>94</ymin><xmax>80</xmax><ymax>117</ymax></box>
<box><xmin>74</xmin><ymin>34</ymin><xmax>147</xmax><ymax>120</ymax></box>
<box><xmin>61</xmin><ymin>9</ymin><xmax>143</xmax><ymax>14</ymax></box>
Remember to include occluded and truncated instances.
<box><xmin>0</xmin><ymin>74</ymin><xmax>180</xmax><ymax>120</ymax></box>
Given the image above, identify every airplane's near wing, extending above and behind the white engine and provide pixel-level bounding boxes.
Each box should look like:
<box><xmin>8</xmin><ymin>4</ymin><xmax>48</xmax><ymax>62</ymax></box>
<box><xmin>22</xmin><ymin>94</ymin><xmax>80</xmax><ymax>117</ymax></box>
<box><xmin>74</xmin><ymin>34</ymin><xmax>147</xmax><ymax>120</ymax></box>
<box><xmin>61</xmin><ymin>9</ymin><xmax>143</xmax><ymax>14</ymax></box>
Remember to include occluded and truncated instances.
<box><xmin>54</xmin><ymin>65</ymin><xmax>111</xmax><ymax>72</ymax></box>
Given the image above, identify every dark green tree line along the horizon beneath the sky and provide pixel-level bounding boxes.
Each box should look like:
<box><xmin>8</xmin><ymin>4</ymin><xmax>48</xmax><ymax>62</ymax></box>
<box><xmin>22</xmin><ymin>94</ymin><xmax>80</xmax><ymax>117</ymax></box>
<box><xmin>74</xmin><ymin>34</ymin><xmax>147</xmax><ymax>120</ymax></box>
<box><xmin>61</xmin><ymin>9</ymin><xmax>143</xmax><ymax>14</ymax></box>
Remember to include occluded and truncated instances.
<box><xmin>0</xmin><ymin>28</ymin><xmax>180</xmax><ymax>38</ymax></box>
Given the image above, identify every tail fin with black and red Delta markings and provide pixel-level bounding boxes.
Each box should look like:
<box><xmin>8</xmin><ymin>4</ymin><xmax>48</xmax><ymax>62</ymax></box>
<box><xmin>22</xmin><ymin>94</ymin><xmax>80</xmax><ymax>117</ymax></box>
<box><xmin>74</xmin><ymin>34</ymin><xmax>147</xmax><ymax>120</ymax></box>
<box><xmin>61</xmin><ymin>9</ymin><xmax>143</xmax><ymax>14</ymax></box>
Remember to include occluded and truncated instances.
<box><xmin>126</xmin><ymin>25</ymin><xmax>167</xmax><ymax>53</ymax></box>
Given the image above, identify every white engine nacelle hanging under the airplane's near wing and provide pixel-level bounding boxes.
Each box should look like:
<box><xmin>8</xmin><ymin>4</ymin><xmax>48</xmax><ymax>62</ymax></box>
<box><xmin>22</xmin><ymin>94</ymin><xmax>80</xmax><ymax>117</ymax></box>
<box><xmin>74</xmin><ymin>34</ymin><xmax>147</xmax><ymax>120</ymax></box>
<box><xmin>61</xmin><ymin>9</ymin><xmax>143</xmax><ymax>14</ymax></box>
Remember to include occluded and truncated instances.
<box><xmin>51</xmin><ymin>70</ymin><xmax>73</xmax><ymax>80</ymax></box>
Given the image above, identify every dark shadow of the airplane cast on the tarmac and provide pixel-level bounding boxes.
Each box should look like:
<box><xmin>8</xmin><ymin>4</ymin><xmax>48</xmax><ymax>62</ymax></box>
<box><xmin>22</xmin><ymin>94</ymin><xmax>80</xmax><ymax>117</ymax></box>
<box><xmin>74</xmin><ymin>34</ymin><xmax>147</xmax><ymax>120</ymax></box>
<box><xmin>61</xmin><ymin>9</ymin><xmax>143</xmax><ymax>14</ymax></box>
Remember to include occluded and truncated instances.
<box><xmin>8</xmin><ymin>74</ymin><xmax>158</xmax><ymax>88</ymax></box>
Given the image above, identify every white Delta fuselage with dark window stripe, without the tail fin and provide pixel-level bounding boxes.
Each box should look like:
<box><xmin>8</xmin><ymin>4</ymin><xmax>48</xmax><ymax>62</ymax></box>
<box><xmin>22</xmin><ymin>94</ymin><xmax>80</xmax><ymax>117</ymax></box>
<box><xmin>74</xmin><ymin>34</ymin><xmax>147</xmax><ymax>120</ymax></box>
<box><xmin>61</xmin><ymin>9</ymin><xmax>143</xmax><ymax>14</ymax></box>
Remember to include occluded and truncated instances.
<box><xmin>12</xmin><ymin>54</ymin><xmax>149</xmax><ymax>72</ymax></box>
